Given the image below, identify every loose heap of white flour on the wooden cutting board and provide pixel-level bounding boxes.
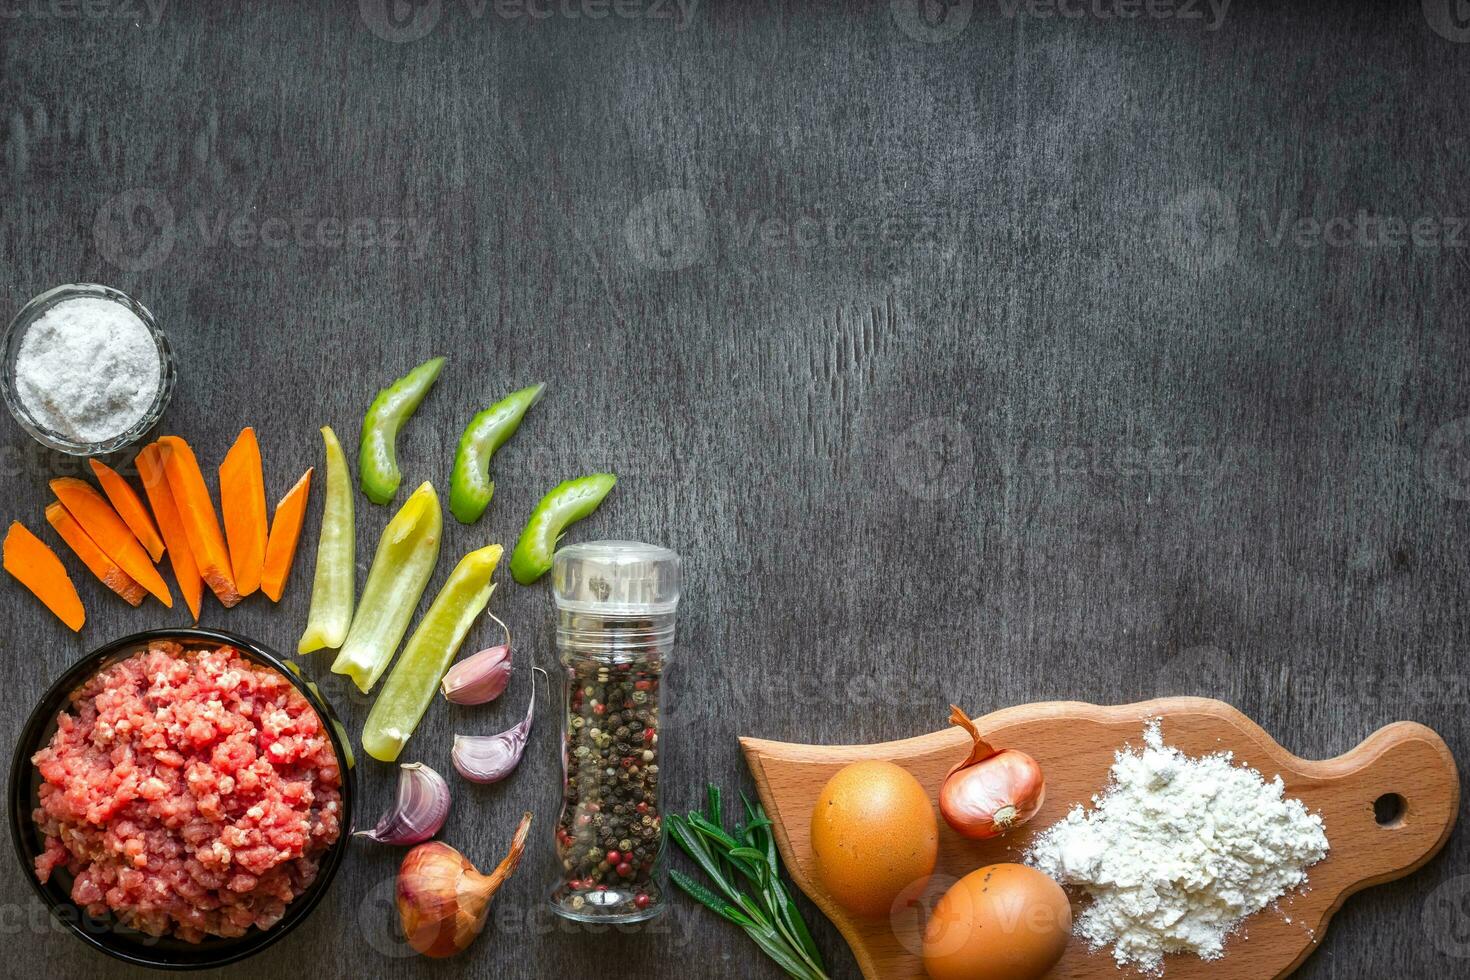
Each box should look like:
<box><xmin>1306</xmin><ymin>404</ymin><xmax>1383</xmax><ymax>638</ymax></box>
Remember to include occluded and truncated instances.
<box><xmin>1026</xmin><ymin>720</ymin><xmax>1327</xmax><ymax>976</ymax></box>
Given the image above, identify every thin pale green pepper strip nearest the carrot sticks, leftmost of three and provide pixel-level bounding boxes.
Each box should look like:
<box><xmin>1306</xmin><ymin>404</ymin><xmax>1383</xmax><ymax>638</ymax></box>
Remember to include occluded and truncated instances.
<box><xmin>295</xmin><ymin>426</ymin><xmax>357</xmax><ymax>654</ymax></box>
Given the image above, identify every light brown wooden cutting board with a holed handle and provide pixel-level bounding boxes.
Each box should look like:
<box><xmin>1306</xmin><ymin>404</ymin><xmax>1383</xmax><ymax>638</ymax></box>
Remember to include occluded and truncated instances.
<box><xmin>741</xmin><ymin>698</ymin><xmax>1460</xmax><ymax>980</ymax></box>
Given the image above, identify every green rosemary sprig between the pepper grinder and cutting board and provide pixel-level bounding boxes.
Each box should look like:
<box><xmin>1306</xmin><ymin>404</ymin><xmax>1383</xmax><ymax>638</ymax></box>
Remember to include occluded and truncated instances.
<box><xmin>664</xmin><ymin>785</ymin><xmax>828</xmax><ymax>980</ymax></box>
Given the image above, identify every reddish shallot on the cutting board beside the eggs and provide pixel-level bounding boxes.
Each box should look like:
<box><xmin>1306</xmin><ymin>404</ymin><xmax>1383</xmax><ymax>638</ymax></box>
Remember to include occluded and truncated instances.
<box><xmin>939</xmin><ymin>705</ymin><xmax>1047</xmax><ymax>840</ymax></box>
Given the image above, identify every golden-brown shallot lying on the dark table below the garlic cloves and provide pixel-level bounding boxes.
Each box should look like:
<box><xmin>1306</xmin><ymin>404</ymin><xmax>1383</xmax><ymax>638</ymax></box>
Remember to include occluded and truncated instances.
<box><xmin>395</xmin><ymin>814</ymin><xmax>531</xmax><ymax>958</ymax></box>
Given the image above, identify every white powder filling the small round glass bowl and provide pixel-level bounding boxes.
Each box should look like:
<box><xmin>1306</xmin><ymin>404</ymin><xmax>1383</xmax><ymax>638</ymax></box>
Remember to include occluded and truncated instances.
<box><xmin>15</xmin><ymin>297</ymin><xmax>163</xmax><ymax>442</ymax></box>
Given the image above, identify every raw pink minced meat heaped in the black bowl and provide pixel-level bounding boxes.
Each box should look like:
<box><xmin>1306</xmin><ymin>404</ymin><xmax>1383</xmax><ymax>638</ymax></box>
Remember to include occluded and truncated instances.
<box><xmin>31</xmin><ymin>642</ymin><xmax>341</xmax><ymax>942</ymax></box>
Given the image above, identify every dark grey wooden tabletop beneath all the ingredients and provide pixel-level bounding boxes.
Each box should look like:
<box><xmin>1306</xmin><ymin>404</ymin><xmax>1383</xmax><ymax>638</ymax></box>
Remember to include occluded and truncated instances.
<box><xmin>0</xmin><ymin>0</ymin><xmax>1470</xmax><ymax>979</ymax></box>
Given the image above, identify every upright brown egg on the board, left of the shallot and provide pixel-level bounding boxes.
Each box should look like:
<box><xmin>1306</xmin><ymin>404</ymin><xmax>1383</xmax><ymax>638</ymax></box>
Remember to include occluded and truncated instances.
<box><xmin>811</xmin><ymin>763</ymin><xmax>939</xmax><ymax>918</ymax></box>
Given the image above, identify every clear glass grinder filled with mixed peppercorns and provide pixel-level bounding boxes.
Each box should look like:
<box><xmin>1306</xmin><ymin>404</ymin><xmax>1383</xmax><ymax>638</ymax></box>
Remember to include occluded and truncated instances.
<box><xmin>551</xmin><ymin>541</ymin><xmax>679</xmax><ymax>923</ymax></box>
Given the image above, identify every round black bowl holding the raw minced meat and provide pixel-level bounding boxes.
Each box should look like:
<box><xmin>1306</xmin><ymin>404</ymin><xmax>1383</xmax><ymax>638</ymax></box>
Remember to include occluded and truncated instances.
<box><xmin>10</xmin><ymin>629</ymin><xmax>356</xmax><ymax>970</ymax></box>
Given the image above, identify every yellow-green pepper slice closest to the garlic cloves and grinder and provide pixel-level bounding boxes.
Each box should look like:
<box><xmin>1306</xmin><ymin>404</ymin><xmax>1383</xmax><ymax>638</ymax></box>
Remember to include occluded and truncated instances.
<box><xmin>363</xmin><ymin>545</ymin><xmax>501</xmax><ymax>763</ymax></box>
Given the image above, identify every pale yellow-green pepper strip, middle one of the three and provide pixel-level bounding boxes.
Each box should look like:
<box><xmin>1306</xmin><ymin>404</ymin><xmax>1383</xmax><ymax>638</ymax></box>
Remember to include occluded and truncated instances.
<box><xmin>332</xmin><ymin>483</ymin><xmax>444</xmax><ymax>693</ymax></box>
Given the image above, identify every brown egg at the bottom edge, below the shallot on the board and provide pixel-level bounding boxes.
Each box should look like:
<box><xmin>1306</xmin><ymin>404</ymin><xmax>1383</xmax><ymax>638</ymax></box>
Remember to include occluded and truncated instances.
<box><xmin>923</xmin><ymin>864</ymin><xmax>1072</xmax><ymax>980</ymax></box>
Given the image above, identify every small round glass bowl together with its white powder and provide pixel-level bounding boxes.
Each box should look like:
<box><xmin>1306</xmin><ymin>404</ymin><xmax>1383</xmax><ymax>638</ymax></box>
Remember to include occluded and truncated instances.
<box><xmin>0</xmin><ymin>282</ymin><xmax>175</xmax><ymax>455</ymax></box>
